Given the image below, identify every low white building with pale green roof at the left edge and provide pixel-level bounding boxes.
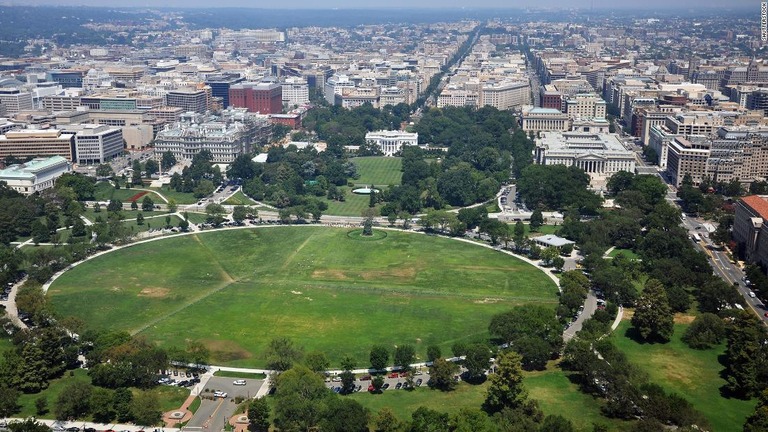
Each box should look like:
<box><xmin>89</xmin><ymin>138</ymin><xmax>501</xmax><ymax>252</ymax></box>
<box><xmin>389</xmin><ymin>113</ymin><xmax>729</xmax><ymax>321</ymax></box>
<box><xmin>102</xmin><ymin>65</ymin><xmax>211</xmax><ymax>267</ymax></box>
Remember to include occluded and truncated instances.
<box><xmin>0</xmin><ymin>156</ymin><xmax>72</xmax><ymax>195</ymax></box>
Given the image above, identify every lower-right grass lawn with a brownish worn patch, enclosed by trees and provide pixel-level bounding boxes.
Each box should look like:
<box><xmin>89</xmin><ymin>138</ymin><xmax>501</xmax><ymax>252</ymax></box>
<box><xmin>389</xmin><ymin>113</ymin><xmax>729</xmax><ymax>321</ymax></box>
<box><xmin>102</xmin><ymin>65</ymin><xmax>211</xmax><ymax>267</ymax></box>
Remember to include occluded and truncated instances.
<box><xmin>612</xmin><ymin>321</ymin><xmax>756</xmax><ymax>431</ymax></box>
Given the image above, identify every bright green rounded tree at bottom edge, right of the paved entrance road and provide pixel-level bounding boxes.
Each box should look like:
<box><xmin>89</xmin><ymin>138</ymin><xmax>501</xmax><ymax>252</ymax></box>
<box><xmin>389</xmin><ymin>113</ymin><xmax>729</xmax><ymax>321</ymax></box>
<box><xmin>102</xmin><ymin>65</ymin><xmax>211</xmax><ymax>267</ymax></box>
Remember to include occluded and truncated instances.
<box><xmin>274</xmin><ymin>365</ymin><xmax>332</xmax><ymax>431</ymax></box>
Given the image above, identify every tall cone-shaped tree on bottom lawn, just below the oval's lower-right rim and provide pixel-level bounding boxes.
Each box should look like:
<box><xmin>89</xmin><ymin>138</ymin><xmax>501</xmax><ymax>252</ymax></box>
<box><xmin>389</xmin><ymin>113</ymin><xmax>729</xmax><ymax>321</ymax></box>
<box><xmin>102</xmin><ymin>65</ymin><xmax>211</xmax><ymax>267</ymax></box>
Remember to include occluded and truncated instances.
<box><xmin>483</xmin><ymin>351</ymin><xmax>528</xmax><ymax>414</ymax></box>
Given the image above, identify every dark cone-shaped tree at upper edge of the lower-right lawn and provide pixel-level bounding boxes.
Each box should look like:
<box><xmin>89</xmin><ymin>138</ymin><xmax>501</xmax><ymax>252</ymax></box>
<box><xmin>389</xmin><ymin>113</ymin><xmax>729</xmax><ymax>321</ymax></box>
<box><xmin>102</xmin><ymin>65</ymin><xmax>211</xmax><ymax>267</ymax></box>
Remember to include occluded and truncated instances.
<box><xmin>632</xmin><ymin>279</ymin><xmax>675</xmax><ymax>342</ymax></box>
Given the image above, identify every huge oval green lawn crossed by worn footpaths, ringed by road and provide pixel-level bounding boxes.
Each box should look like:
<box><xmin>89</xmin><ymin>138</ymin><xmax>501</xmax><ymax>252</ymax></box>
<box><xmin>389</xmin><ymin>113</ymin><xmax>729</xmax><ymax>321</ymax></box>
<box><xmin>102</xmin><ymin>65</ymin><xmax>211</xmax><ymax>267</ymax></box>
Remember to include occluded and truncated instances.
<box><xmin>48</xmin><ymin>227</ymin><xmax>557</xmax><ymax>367</ymax></box>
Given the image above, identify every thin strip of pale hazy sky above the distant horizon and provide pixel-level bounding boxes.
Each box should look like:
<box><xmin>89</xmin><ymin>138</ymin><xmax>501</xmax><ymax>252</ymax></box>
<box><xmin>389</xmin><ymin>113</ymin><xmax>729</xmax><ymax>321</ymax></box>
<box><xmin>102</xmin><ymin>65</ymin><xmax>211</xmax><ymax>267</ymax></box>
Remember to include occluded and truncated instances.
<box><xmin>0</xmin><ymin>0</ymin><xmax>760</xmax><ymax>8</ymax></box>
